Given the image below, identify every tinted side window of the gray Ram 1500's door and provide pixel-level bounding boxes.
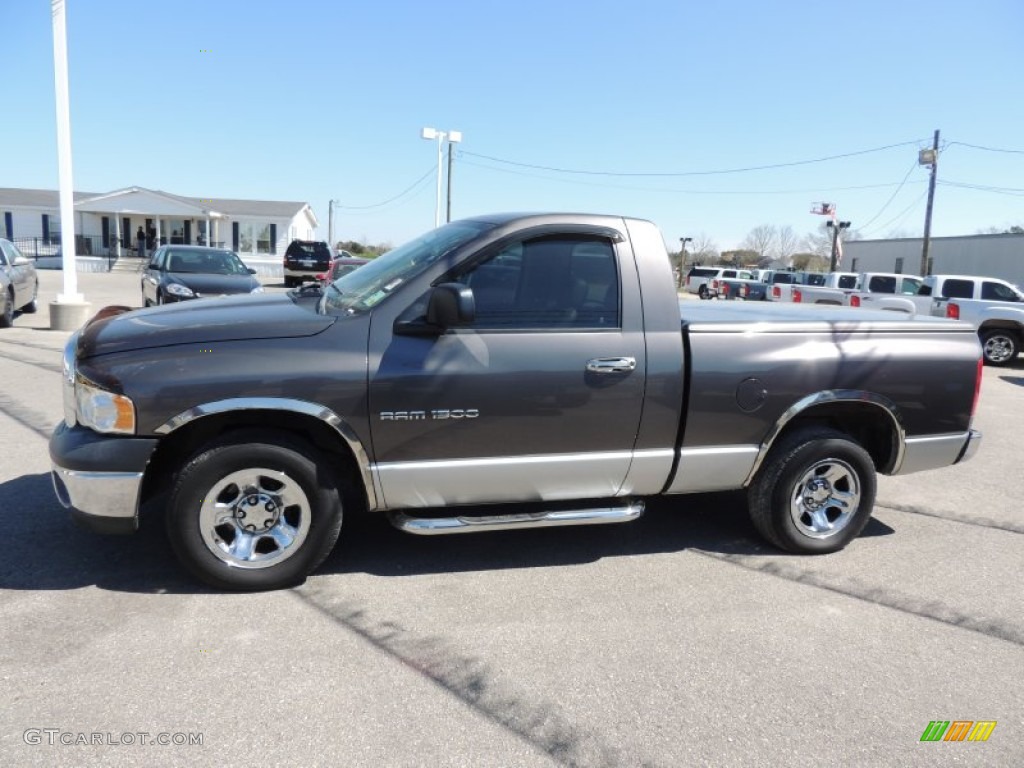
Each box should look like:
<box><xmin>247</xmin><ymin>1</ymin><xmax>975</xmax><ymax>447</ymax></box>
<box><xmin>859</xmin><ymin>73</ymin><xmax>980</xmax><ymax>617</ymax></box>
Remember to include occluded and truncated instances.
<box><xmin>458</xmin><ymin>236</ymin><xmax>620</xmax><ymax>330</ymax></box>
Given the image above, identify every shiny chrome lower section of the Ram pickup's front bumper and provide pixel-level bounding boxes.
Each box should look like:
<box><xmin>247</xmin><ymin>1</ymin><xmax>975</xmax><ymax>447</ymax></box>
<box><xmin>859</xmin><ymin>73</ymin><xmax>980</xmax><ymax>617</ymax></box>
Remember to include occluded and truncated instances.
<box><xmin>50</xmin><ymin>464</ymin><xmax>142</xmax><ymax>532</ymax></box>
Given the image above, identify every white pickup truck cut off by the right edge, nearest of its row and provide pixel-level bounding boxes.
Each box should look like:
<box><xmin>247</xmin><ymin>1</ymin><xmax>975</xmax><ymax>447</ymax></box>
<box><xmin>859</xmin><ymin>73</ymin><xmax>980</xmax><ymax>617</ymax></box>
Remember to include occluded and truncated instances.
<box><xmin>918</xmin><ymin>274</ymin><xmax>1024</xmax><ymax>366</ymax></box>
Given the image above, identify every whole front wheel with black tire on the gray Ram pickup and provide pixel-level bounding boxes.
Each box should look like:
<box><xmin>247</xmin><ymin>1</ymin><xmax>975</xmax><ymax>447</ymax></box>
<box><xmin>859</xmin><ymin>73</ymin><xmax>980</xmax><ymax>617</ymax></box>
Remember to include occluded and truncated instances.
<box><xmin>167</xmin><ymin>430</ymin><xmax>342</xmax><ymax>592</ymax></box>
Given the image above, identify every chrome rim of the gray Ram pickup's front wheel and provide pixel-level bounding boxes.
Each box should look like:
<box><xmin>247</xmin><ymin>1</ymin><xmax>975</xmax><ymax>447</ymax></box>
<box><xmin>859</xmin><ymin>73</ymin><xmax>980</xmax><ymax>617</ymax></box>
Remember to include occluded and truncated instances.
<box><xmin>199</xmin><ymin>467</ymin><xmax>311</xmax><ymax>569</ymax></box>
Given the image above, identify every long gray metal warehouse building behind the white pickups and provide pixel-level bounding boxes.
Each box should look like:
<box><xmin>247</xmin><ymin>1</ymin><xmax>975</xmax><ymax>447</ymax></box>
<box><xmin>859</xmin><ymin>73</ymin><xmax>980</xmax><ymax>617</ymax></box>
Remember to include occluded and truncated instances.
<box><xmin>843</xmin><ymin>234</ymin><xmax>1024</xmax><ymax>286</ymax></box>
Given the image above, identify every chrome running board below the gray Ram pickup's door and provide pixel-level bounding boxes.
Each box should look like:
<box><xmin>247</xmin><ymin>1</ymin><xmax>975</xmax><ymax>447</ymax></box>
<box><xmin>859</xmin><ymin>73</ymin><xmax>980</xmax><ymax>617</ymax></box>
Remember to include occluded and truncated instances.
<box><xmin>388</xmin><ymin>501</ymin><xmax>644</xmax><ymax>536</ymax></box>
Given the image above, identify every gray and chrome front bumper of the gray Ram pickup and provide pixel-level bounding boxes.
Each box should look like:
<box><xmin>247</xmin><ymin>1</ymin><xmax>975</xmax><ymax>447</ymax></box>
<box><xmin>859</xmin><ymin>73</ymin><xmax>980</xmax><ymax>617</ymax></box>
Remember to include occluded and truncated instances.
<box><xmin>50</xmin><ymin>422</ymin><xmax>159</xmax><ymax>534</ymax></box>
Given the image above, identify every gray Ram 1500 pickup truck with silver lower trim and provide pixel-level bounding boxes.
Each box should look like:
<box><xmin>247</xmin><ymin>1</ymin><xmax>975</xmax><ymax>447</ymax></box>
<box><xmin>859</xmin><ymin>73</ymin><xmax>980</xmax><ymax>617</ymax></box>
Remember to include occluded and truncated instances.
<box><xmin>50</xmin><ymin>214</ymin><xmax>981</xmax><ymax>590</ymax></box>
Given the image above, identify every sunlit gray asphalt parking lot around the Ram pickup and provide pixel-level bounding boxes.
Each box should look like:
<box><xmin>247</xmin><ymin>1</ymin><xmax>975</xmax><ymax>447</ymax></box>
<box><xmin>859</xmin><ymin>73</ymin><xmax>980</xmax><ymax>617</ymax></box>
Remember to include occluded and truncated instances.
<box><xmin>0</xmin><ymin>271</ymin><xmax>1024</xmax><ymax>767</ymax></box>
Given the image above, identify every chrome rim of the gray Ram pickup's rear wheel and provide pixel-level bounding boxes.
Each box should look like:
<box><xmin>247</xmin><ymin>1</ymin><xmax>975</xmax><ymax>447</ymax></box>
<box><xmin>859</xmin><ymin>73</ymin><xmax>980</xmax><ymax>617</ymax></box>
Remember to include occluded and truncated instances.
<box><xmin>790</xmin><ymin>459</ymin><xmax>861</xmax><ymax>539</ymax></box>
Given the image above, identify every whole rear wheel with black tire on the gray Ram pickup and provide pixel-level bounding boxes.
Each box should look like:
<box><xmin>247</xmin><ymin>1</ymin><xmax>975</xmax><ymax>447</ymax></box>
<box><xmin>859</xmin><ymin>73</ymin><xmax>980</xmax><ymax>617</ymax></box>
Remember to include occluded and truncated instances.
<box><xmin>748</xmin><ymin>427</ymin><xmax>877</xmax><ymax>554</ymax></box>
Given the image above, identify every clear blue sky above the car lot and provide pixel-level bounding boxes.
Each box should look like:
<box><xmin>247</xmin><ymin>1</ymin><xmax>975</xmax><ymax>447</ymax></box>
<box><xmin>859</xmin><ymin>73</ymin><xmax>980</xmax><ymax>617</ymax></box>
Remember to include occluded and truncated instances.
<box><xmin>0</xmin><ymin>0</ymin><xmax>1024</xmax><ymax>249</ymax></box>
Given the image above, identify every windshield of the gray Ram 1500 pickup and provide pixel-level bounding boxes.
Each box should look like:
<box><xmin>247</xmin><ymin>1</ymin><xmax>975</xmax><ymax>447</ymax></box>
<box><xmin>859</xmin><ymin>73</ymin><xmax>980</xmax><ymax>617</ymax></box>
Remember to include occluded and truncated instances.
<box><xmin>319</xmin><ymin>221</ymin><xmax>495</xmax><ymax>314</ymax></box>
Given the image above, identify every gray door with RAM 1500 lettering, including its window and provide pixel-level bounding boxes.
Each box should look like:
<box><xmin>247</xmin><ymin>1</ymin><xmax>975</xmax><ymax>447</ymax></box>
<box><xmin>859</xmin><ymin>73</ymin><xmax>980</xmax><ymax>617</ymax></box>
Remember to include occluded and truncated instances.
<box><xmin>370</xmin><ymin>232</ymin><xmax>646</xmax><ymax>509</ymax></box>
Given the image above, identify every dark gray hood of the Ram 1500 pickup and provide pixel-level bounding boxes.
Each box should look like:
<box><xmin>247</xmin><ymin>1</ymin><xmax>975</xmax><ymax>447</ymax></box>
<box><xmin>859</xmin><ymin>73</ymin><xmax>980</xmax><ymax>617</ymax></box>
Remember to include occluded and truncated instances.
<box><xmin>78</xmin><ymin>294</ymin><xmax>337</xmax><ymax>357</ymax></box>
